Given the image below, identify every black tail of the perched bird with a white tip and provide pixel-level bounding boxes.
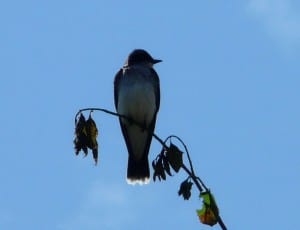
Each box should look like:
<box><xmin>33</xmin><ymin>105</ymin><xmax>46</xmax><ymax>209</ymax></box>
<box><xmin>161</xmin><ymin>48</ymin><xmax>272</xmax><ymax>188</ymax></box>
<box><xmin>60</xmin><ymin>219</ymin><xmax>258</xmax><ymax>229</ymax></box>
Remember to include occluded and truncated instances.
<box><xmin>127</xmin><ymin>154</ymin><xmax>150</xmax><ymax>184</ymax></box>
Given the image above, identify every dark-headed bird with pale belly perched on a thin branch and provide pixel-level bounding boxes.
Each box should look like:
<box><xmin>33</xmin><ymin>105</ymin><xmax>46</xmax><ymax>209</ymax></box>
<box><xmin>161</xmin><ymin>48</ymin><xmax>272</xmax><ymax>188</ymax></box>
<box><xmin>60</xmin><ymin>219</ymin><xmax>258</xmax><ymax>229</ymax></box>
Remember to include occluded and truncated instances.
<box><xmin>114</xmin><ymin>49</ymin><xmax>162</xmax><ymax>185</ymax></box>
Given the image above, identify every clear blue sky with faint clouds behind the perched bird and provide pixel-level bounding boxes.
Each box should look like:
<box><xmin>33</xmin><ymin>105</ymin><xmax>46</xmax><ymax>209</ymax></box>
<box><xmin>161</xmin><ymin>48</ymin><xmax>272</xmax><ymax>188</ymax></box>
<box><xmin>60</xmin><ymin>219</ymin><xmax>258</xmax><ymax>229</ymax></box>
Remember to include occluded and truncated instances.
<box><xmin>0</xmin><ymin>0</ymin><xmax>300</xmax><ymax>230</ymax></box>
